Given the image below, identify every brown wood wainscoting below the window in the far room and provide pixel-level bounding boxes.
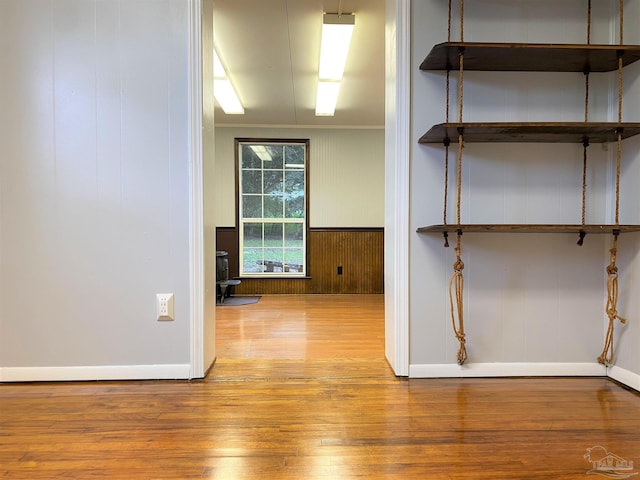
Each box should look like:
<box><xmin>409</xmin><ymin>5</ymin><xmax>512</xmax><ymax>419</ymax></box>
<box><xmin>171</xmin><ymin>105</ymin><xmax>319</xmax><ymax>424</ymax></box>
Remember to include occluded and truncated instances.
<box><xmin>216</xmin><ymin>227</ymin><xmax>384</xmax><ymax>295</ymax></box>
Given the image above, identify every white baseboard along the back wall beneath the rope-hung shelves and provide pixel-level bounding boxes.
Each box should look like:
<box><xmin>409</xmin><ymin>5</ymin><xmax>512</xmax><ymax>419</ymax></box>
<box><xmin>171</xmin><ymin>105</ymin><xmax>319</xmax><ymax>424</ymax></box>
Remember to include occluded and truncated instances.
<box><xmin>409</xmin><ymin>363</ymin><xmax>607</xmax><ymax>378</ymax></box>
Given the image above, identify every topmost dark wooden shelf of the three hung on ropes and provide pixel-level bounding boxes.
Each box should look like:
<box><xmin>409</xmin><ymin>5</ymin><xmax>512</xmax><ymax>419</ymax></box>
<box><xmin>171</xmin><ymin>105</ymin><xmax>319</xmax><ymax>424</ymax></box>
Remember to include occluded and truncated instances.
<box><xmin>420</xmin><ymin>42</ymin><xmax>640</xmax><ymax>73</ymax></box>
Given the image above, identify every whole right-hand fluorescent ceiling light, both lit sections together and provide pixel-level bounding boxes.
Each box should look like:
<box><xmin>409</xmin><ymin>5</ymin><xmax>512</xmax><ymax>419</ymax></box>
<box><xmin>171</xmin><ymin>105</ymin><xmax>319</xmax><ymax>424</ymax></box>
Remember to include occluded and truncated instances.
<box><xmin>316</xmin><ymin>13</ymin><xmax>356</xmax><ymax>117</ymax></box>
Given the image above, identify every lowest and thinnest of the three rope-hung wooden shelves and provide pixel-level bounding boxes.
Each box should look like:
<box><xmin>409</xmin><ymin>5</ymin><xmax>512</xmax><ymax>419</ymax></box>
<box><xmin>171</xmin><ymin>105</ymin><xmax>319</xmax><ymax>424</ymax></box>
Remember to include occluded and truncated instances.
<box><xmin>417</xmin><ymin>223</ymin><xmax>640</xmax><ymax>234</ymax></box>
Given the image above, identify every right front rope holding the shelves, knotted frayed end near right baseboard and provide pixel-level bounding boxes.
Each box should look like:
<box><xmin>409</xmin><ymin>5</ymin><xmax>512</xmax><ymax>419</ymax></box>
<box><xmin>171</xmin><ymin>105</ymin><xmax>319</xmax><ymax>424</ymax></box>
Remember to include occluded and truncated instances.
<box><xmin>598</xmin><ymin>0</ymin><xmax>627</xmax><ymax>366</ymax></box>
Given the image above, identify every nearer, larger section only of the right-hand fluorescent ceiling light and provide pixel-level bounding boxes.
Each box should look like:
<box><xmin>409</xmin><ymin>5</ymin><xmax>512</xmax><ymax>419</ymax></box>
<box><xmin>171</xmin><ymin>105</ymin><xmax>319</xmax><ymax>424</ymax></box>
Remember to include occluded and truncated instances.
<box><xmin>318</xmin><ymin>13</ymin><xmax>356</xmax><ymax>80</ymax></box>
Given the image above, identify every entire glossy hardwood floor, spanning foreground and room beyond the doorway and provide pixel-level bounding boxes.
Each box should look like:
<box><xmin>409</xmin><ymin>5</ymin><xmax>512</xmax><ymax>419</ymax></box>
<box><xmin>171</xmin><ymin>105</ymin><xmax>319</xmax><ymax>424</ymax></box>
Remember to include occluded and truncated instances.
<box><xmin>0</xmin><ymin>296</ymin><xmax>640</xmax><ymax>480</ymax></box>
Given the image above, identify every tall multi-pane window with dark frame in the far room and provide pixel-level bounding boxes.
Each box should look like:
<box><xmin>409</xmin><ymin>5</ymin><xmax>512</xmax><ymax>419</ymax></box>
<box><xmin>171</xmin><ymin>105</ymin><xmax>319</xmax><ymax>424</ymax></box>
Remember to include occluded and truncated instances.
<box><xmin>236</xmin><ymin>139</ymin><xmax>309</xmax><ymax>277</ymax></box>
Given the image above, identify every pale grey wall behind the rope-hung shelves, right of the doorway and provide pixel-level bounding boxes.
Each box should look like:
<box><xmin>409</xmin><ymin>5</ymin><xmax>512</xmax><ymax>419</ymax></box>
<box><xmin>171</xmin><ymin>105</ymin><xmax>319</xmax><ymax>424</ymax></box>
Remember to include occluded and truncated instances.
<box><xmin>410</xmin><ymin>0</ymin><xmax>637</xmax><ymax>376</ymax></box>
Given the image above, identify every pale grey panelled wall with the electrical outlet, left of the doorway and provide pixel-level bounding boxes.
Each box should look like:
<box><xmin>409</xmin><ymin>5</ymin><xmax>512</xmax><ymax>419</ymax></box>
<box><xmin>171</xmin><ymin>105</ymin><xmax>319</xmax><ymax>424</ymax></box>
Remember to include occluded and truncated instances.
<box><xmin>0</xmin><ymin>0</ymin><xmax>194</xmax><ymax>379</ymax></box>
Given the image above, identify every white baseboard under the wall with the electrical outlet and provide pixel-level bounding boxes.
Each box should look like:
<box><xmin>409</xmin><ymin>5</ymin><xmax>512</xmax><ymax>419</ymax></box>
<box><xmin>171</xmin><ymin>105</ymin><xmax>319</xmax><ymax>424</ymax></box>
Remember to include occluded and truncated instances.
<box><xmin>0</xmin><ymin>364</ymin><xmax>191</xmax><ymax>382</ymax></box>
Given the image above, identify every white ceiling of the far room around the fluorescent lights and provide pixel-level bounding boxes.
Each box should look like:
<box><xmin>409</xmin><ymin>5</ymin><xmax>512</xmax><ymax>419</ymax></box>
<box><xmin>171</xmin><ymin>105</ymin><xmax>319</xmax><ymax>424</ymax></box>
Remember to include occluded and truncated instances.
<box><xmin>214</xmin><ymin>0</ymin><xmax>385</xmax><ymax>126</ymax></box>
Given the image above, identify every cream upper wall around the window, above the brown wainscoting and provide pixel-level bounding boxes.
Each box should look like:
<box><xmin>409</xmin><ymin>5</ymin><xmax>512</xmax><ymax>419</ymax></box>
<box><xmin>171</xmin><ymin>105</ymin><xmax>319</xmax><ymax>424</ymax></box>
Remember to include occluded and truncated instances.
<box><xmin>212</xmin><ymin>126</ymin><xmax>384</xmax><ymax>228</ymax></box>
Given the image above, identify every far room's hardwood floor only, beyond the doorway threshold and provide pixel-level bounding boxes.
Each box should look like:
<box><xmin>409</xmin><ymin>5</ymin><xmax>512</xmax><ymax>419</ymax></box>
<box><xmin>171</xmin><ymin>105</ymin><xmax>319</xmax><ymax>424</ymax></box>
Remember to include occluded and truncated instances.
<box><xmin>216</xmin><ymin>295</ymin><xmax>384</xmax><ymax>360</ymax></box>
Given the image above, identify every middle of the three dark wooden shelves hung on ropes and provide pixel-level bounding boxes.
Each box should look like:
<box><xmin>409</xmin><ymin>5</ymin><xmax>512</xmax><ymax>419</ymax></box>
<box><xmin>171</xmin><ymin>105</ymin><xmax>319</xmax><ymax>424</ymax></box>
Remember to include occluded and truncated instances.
<box><xmin>418</xmin><ymin>122</ymin><xmax>640</xmax><ymax>143</ymax></box>
